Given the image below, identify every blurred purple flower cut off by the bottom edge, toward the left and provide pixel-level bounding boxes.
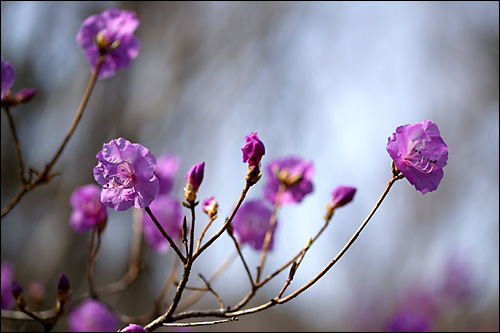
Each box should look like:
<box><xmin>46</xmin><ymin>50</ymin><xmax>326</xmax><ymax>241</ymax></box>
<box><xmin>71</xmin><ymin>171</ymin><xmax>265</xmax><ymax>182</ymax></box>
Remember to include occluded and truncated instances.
<box><xmin>68</xmin><ymin>299</ymin><xmax>118</xmax><ymax>332</ymax></box>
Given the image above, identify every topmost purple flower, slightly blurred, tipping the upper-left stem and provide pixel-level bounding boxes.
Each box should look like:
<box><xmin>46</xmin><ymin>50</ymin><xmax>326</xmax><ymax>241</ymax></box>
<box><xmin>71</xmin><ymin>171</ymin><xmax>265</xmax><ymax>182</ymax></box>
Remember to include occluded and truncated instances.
<box><xmin>76</xmin><ymin>8</ymin><xmax>139</xmax><ymax>78</ymax></box>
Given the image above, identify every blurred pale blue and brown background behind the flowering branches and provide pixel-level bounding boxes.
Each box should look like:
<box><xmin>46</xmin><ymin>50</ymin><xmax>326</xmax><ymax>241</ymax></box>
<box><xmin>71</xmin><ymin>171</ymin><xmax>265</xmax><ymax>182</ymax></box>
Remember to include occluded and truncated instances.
<box><xmin>1</xmin><ymin>1</ymin><xmax>499</xmax><ymax>331</ymax></box>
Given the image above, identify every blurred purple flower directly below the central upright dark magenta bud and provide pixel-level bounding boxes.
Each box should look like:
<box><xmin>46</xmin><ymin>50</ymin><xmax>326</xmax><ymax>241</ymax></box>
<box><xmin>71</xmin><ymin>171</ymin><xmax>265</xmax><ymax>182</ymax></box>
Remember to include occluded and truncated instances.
<box><xmin>232</xmin><ymin>200</ymin><xmax>278</xmax><ymax>250</ymax></box>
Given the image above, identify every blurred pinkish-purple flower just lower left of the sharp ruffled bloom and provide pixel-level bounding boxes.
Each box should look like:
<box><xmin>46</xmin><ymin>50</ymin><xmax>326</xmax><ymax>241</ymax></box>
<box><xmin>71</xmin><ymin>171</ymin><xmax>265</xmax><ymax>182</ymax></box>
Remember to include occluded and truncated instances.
<box><xmin>69</xmin><ymin>184</ymin><xmax>107</xmax><ymax>232</ymax></box>
